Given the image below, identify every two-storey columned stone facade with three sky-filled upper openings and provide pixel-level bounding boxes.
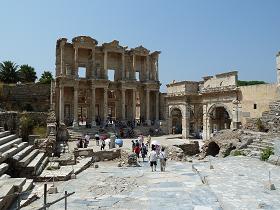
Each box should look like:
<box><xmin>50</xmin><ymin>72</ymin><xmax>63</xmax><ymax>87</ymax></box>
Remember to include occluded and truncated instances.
<box><xmin>54</xmin><ymin>36</ymin><xmax>160</xmax><ymax>126</ymax></box>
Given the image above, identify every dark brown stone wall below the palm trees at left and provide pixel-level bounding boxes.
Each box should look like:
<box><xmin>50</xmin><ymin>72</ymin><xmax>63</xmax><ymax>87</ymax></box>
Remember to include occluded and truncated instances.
<box><xmin>0</xmin><ymin>83</ymin><xmax>50</xmax><ymax>112</ymax></box>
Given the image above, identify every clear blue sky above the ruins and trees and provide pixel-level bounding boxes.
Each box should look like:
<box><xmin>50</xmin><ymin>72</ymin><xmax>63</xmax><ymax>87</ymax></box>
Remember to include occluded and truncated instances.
<box><xmin>0</xmin><ymin>0</ymin><xmax>280</xmax><ymax>90</ymax></box>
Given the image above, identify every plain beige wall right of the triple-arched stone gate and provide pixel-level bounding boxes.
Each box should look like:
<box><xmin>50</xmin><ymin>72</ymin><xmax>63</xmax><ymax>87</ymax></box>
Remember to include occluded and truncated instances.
<box><xmin>239</xmin><ymin>84</ymin><xmax>280</xmax><ymax>125</ymax></box>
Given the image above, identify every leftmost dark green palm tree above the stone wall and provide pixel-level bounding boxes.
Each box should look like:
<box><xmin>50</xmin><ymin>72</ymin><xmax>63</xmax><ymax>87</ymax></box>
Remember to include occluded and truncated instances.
<box><xmin>0</xmin><ymin>61</ymin><xmax>19</xmax><ymax>83</ymax></box>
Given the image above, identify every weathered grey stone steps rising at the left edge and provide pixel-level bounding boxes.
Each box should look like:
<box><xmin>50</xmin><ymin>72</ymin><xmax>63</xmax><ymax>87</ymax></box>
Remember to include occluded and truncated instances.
<box><xmin>0</xmin><ymin>127</ymin><xmax>48</xmax><ymax>210</ymax></box>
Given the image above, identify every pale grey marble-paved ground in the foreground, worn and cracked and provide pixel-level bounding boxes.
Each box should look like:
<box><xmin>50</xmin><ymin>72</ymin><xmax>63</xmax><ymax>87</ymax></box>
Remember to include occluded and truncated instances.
<box><xmin>21</xmin><ymin>157</ymin><xmax>280</xmax><ymax>210</ymax></box>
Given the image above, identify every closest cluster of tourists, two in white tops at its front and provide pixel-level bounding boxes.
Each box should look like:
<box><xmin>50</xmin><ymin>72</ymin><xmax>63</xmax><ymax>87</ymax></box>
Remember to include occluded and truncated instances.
<box><xmin>131</xmin><ymin>135</ymin><xmax>167</xmax><ymax>171</ymax></box>
